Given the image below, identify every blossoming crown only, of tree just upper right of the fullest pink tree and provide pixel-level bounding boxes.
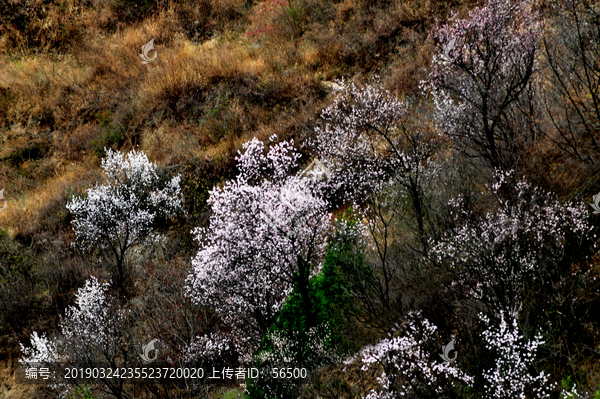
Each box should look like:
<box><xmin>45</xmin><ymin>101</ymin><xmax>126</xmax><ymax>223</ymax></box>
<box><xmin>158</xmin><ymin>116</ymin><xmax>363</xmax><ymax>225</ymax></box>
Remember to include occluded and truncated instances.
<box><xmin>313</xmin><ymin>81</ymin><xmax>406</xmax><ymax>206</ymax></box>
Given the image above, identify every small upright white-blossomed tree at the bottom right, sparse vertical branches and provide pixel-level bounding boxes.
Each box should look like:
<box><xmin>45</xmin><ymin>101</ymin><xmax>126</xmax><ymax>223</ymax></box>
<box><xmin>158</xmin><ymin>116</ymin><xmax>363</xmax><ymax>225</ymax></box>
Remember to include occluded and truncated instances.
<box><xmin>480</xmin><ymin>311</ymin><xmax>551</xmax><ymax>399</ymax></box>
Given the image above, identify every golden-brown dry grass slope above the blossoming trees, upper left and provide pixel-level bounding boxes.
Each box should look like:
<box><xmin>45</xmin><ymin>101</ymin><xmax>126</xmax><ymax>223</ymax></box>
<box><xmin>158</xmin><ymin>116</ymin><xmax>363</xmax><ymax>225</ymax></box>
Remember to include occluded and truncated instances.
<box><xmin>0</xmin><ymin>0</ymin><xmax>474</xmax><ymax>239</ymax></box>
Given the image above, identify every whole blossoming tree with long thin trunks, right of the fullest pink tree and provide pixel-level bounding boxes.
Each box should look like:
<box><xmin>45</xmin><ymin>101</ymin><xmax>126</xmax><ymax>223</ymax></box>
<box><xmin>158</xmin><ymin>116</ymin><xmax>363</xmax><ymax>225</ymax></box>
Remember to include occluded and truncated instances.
<box><xmin>312</xmin><ymin>81</ymin><xmax>443</xmax><ymax>330</ymax></box>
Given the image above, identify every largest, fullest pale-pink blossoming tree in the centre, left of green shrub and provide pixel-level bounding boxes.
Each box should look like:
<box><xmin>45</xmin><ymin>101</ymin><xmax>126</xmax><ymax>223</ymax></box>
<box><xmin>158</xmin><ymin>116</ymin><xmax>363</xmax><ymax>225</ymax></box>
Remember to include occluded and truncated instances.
<box><xmin>188</xmin><ymin>138</ymin><xmax>330</xmax><ymax>361</ymax></box>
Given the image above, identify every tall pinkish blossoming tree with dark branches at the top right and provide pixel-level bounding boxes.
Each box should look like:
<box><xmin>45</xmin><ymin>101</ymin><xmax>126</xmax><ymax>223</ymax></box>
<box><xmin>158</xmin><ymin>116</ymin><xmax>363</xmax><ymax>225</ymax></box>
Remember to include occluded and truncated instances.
<box><xmin>425</xmin><ymin>0</ymin><xmax>540</xmax><ymax>169</ymax></box>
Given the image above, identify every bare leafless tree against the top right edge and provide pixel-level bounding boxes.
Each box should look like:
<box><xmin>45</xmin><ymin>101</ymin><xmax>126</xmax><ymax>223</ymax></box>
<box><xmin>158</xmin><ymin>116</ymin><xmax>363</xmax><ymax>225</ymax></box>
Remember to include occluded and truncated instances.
<box><xmin>541</xmin><ymin>0</ymin><xmax>600</xmax><ymax>165</ymax></box>
